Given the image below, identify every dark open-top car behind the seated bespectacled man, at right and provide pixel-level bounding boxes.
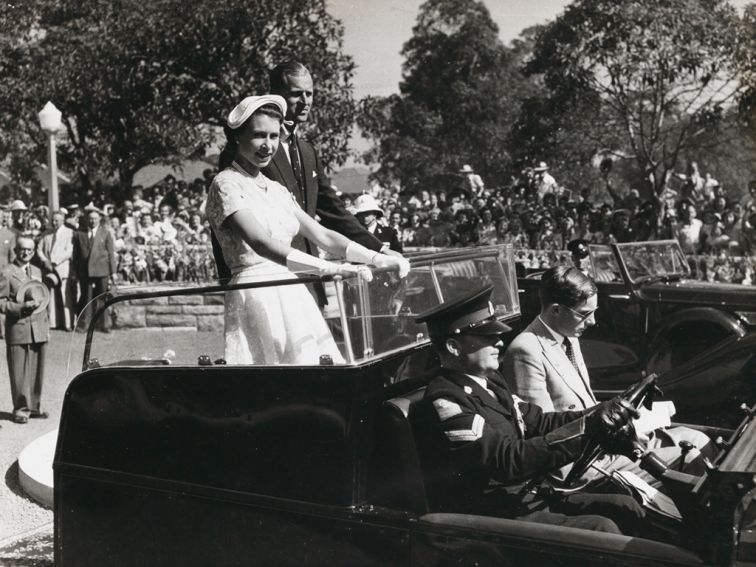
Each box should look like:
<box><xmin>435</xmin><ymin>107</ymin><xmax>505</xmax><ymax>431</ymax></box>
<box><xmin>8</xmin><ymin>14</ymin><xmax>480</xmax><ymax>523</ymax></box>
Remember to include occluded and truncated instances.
<box><xmin>518</xmin><ymin>240</ymin><xmax>756</xmax><ymax>426</ymax></box>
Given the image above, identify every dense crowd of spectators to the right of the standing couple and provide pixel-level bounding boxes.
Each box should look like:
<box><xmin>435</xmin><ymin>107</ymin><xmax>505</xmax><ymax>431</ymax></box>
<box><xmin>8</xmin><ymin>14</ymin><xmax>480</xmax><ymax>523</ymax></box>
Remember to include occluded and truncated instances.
<box><xmin>347</xmin><ymin>162</ymin><xmax>756</xmax><ymax>283</ymax></box>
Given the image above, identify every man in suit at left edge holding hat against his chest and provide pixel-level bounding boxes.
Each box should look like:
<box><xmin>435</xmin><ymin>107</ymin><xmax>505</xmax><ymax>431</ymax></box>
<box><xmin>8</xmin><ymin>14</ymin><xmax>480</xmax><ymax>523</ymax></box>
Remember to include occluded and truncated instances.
<box><xmin>0</xmin><ymin>236</ymin><xmax>49</xmax><ymax>423</ymax></box>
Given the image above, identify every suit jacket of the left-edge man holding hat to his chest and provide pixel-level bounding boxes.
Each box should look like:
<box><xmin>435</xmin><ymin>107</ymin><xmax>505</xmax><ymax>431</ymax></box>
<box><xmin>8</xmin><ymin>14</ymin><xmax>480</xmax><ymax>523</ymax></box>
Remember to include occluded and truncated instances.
<box><xmin>0</xmin><ymin>263</ymin><xmax>50</xmax><ymax>345</ymax></box>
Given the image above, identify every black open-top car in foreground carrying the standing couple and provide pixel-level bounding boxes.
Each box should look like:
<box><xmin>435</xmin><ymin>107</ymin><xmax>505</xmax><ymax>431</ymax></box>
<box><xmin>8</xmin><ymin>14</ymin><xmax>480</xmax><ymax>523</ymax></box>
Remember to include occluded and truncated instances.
<box><xmin>54</xmin><ymin>246</ymin><xmax>756</xmax><ymax>567</ymax></box>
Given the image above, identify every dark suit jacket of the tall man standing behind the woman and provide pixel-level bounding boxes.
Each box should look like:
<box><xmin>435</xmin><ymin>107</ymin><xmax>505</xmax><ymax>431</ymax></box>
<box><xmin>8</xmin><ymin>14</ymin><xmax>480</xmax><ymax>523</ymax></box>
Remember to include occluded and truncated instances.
<box><xmin>262</xmin><ymin>136</ymin><xmax>383</xmax><ymax>251</ymax></box>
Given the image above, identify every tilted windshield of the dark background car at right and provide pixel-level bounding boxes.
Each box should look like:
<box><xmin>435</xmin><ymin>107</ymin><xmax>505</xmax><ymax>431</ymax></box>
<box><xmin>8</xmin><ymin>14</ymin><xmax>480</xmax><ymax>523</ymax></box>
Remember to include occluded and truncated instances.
<box><xmin>617</xmin><ymin>240</ymin><xmax>690</xmax><ymax>283</ymax></box>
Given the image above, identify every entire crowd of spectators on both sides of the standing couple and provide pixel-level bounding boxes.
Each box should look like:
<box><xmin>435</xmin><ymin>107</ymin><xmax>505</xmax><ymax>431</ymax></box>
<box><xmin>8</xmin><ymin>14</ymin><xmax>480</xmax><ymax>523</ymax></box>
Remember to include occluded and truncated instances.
<box><xmin>0</xmin><ymin>162</ymin><xmax>756</xmax><ymax>283</ymax></box>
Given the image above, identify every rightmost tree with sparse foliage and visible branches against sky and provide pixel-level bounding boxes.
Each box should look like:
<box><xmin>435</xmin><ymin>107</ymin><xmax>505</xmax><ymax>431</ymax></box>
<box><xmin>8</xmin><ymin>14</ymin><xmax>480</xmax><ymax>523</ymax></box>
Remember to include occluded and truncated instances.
<box><xmin>516</xmin><ymin>0</ymin><xmax>746</xmax><ymax>200</ymax></box>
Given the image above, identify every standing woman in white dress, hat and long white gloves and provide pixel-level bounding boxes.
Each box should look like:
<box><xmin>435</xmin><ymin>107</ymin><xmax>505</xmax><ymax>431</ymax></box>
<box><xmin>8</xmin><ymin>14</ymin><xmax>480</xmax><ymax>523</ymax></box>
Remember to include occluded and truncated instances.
<box><xmin>206</xmin><ymin>95</ymin><xmax>409</xmax><ymax>364</ymax></box>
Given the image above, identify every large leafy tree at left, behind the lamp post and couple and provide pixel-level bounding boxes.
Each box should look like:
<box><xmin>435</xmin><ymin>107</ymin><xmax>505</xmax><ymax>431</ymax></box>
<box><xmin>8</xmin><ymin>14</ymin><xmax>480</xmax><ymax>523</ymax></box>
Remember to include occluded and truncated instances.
<box><xmin>0</xmin><ymin>0</ymin><xmax>355</xmax><ymax>196</ymax></box>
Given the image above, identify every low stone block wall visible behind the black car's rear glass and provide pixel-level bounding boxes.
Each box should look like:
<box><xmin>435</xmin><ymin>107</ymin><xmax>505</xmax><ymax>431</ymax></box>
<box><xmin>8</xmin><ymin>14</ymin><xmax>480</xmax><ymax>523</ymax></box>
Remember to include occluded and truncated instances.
<box><xmin>111</xmin><ymin>290</ymin><xmax>224</xmax><ymax>332</ymax></box>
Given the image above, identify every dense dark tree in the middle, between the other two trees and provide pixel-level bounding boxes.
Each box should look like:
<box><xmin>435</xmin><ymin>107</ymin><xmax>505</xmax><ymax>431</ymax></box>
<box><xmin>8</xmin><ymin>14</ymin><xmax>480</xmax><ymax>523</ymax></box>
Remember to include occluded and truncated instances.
<box><xmin>357</xmin><ymin>0</ymin><xmax>534</xmax><ymax>191</ymax></box>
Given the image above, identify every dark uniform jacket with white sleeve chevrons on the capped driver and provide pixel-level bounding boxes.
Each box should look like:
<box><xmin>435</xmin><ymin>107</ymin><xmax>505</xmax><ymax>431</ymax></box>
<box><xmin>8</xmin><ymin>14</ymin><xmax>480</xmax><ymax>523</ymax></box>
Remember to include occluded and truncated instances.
<box><xmin>415</xmin><ymin>368</ymin><xmax>585</xmax><ymax>511</ymax></box>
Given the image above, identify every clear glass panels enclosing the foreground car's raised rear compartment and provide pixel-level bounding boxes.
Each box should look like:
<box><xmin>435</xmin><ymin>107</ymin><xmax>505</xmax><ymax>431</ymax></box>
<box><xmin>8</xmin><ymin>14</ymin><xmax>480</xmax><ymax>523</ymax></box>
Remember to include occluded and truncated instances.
<box><xmin>69</xmin><ymin>245</ymin><xmax>520</xmax><ymax>375</ymax></box>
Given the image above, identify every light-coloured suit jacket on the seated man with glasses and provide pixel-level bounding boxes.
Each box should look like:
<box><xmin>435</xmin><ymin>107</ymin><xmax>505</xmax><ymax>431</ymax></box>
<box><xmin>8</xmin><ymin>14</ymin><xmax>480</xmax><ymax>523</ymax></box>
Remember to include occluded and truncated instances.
<box><xmin>501</xmin><ymin>317</ymin><xmax>596</xmax><ymax>411</ymax></box>
